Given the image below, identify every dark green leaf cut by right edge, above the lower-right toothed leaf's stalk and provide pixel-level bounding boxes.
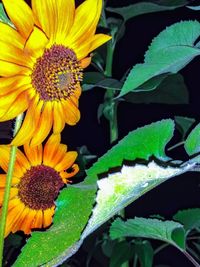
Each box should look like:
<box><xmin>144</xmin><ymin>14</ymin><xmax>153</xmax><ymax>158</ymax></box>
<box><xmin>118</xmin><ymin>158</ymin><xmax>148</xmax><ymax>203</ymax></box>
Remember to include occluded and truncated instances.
<box><xmin>173</xmin><ymin>208</ymin><xmax>200</xmax><ymax>233</ymax></box>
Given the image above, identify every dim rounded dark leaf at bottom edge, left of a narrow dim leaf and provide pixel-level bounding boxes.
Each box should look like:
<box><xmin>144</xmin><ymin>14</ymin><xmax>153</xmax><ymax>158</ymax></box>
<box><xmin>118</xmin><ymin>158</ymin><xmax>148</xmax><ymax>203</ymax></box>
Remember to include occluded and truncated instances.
<box><xmin>109</xmin><ymin>241</ymin><xmax>133</xmax><ymax>267</ymax></box>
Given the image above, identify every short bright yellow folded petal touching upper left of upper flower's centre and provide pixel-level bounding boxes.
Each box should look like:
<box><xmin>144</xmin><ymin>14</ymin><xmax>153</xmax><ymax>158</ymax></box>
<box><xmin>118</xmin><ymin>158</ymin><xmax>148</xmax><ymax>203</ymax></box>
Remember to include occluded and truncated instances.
<box><xmin>24</xmin><ymin>27</ymin><xmax>48</xmax><ymax>58</ymax></box>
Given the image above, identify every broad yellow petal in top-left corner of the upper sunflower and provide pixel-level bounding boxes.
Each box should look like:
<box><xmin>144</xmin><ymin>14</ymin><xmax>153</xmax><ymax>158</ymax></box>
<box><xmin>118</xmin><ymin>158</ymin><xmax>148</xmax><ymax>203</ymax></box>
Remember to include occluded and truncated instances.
<box><xmin>2</xmin><ymin>0</ymin><xmax>34</xmax><ymax>38</ymax></box>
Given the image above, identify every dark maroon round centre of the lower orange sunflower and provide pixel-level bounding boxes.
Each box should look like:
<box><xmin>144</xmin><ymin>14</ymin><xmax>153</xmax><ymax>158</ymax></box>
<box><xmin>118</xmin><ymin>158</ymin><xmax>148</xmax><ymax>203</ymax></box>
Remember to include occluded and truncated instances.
<box><xmin>19</xmin><ymin>165</ymin><xmax>64</xmax><ymax>210</ymax></box>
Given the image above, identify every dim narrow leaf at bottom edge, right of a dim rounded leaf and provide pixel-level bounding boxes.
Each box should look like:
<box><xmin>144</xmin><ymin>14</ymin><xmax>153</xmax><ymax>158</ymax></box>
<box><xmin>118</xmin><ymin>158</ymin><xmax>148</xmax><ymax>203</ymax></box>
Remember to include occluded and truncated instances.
<box><xmin>134</xmin><ymin>240</ymin><xmax>154</xmax><ymax>267</ymax></box>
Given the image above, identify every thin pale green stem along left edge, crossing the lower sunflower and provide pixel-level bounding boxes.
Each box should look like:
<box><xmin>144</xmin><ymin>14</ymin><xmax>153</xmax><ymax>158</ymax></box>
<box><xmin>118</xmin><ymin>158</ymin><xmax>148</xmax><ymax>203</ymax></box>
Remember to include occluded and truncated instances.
<box><xmin>0</xmin><ymin>113</ymin><xmax>23</xmax><ymax>267</ymax></box>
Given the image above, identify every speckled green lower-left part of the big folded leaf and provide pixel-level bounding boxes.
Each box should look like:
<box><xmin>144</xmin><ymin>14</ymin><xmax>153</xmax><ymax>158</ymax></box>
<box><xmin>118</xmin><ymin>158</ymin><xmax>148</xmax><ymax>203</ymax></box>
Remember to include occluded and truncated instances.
<box><xmin>13</xmin><ymin>187</ymin><xmax>96</xmax><ymax>267</ymax></box>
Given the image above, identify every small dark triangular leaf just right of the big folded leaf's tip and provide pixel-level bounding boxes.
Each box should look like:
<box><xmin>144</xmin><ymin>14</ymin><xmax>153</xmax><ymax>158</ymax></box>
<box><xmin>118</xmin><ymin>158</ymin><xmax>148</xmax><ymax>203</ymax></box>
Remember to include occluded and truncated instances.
<box><xmin>174</xmin><ymin>116</ymin><xmax>195</xmax><ymax>140</ymax></box>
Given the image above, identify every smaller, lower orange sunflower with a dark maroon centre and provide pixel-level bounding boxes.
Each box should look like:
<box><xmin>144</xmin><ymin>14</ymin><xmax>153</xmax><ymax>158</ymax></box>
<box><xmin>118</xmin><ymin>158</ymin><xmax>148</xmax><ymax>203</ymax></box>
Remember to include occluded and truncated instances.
<box><xmin>0</xmin><ymin>134</ymin><xmax>79</xmax><ymax>236</ymax></box>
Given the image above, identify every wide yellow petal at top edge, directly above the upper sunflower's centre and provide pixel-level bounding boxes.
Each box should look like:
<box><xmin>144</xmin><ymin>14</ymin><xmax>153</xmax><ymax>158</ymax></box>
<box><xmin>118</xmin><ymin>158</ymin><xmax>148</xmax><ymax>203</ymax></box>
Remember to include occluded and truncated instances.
<box><xmin>32</xmin><ymin>0</ymin><xmax>75</xmax><ymax>41</ymax></box>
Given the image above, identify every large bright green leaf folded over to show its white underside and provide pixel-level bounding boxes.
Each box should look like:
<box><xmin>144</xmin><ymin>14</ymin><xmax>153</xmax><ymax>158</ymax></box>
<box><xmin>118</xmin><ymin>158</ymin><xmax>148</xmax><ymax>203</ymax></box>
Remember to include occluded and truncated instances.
<box><xmin>13</xmin><ymin>120</ymin><xmax>194</xmax><ymax>267</ymax></box>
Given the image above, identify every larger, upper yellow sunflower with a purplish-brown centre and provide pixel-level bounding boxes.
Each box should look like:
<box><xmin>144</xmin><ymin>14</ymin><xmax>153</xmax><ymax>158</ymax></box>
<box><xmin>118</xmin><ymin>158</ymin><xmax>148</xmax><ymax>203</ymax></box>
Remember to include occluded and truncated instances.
<box><xmin>0</xmin><ymin>0</ymin><xmax>111</xmax><ymax>146</ymax></box>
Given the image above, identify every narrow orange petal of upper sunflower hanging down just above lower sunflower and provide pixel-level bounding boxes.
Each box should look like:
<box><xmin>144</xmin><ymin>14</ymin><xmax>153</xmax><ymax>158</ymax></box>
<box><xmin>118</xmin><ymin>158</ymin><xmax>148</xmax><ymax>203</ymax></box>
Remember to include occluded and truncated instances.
<box><xmin>31</xmin><ymin>102</ymin><xmax>53</xmax><ymax>146</ymax></box>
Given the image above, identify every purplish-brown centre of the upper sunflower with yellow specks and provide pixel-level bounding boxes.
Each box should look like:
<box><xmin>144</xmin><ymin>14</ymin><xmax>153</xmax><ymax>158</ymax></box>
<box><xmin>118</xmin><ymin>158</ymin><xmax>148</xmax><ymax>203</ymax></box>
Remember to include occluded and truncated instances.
<box><xmin>31</xmin><ymin>45</ymin><xmax>83</xmax><ymax>101</ymax></box>
